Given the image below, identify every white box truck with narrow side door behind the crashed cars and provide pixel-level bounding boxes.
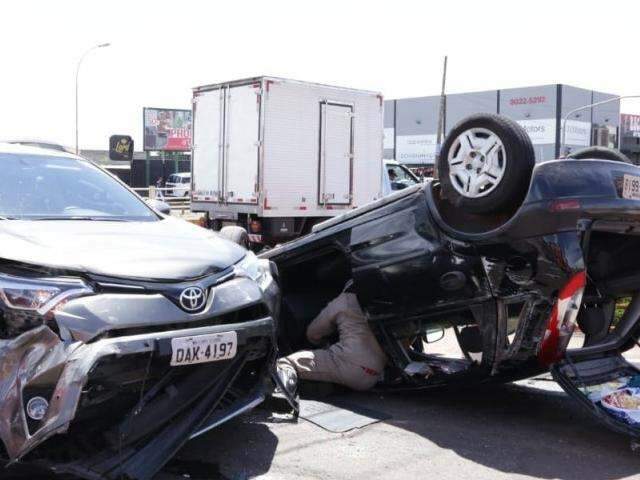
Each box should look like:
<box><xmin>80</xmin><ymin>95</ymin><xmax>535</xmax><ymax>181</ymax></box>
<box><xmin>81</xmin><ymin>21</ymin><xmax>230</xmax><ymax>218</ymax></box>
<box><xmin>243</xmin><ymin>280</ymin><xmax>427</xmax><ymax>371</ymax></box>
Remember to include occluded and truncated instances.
<box><xmin>191</xmin><ymin>77</ymin><xmax>383</xmax><ymax>245</ymax></box>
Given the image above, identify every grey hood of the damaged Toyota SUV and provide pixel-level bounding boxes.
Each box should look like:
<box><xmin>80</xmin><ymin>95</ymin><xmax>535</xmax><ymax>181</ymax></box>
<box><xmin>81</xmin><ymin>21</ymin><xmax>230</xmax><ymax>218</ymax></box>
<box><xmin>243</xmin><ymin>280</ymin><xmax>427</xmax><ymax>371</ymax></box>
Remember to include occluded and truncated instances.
<box><xmin>0</xmin><ymin>217</ymin><xmax>245</xmax><ymax>281</ymax></box>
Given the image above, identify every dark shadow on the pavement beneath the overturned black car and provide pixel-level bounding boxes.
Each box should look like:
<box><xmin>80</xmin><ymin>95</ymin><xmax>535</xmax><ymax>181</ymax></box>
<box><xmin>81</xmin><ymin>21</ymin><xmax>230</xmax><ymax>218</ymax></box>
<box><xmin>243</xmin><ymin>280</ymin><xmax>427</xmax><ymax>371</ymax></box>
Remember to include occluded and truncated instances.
<box><xmin>356</xmin><ymin>385</ymin><xmax>640</xmax><ymax>480</ymax></box>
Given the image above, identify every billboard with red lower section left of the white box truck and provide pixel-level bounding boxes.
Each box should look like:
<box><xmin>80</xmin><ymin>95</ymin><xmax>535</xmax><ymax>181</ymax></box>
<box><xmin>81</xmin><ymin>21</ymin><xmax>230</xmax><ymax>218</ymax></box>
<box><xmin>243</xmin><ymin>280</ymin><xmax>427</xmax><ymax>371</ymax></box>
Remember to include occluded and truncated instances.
<box><xmin>143</xmin><ymin>108</ymin><xmax>192</xmax><ymax>152</ymax></box>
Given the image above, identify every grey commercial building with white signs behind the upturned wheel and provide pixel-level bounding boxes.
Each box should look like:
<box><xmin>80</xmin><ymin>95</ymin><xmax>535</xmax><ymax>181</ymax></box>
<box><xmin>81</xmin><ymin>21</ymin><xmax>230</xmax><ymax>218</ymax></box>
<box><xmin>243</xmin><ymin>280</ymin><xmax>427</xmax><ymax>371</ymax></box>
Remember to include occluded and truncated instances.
<box><xmin>384</xmin><ymin>84</ymin><xmax>620</xmax><ymax>166</ymax></box>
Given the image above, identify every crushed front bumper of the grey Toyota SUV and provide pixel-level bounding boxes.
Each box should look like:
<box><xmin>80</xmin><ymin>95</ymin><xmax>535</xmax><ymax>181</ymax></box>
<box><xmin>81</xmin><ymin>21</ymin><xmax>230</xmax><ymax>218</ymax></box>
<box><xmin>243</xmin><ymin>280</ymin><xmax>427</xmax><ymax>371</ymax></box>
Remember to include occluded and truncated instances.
<box><xmin>0</xmin><ymin>316</ymin><xmax>276</xmax><ymax>479</ymax></box>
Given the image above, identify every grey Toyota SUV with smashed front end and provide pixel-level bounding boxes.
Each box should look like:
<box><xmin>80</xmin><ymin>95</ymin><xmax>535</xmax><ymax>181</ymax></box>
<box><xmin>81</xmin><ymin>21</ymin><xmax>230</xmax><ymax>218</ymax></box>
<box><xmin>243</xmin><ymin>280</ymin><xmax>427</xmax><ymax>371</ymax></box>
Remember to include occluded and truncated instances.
<box><xmin>0</xmin><ymin>145</ymin><xmax>279</xmax><ymax>479</ymax></box>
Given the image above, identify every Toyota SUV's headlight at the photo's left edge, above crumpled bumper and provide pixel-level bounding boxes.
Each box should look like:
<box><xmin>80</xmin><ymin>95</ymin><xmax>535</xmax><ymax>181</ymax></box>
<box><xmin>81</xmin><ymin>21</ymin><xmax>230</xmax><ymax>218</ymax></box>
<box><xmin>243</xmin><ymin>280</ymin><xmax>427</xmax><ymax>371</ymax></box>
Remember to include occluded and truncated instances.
<box><xmin>0</xmin><ymin>274</ymin><xmax>93</xmax><ymax>338</ymax></box>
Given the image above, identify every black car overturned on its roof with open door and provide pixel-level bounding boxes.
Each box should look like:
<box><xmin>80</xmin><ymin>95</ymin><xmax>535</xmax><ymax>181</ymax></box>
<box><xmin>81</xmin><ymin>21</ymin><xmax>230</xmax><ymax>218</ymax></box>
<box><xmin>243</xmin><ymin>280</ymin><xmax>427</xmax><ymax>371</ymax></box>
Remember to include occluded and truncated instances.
<box><xmin>263</xmin><ymin>115</ymin><xmax>640</xmax><ymax>436</ymax></box>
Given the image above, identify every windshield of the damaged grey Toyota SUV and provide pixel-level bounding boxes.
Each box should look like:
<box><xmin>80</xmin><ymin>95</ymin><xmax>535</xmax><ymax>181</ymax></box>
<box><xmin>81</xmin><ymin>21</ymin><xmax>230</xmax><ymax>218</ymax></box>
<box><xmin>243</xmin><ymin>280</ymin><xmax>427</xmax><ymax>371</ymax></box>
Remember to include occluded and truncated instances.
<box><xmin>0</xmin><ymin>153</ymin><xmax>158</xmax><ymax>221</ymax></box>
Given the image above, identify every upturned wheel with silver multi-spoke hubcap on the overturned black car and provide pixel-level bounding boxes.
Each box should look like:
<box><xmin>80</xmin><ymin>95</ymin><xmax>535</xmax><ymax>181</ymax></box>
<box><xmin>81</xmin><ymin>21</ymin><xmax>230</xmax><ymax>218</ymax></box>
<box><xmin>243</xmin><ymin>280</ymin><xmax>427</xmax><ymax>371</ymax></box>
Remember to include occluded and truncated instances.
<box><xmin>438</xmin><ymin>113</ymin><xmax>535</xmax><ymax>214</ymax></box>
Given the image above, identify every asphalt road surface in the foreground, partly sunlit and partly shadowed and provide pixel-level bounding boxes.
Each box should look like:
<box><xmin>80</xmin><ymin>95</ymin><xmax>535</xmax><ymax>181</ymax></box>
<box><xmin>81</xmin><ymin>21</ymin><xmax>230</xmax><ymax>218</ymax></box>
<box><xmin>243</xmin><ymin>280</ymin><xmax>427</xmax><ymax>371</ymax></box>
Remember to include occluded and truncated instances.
<box><xmin>179</xmin><ymin>372</ymin><xmax>640</xmax><ymax>480</ymax></box>
